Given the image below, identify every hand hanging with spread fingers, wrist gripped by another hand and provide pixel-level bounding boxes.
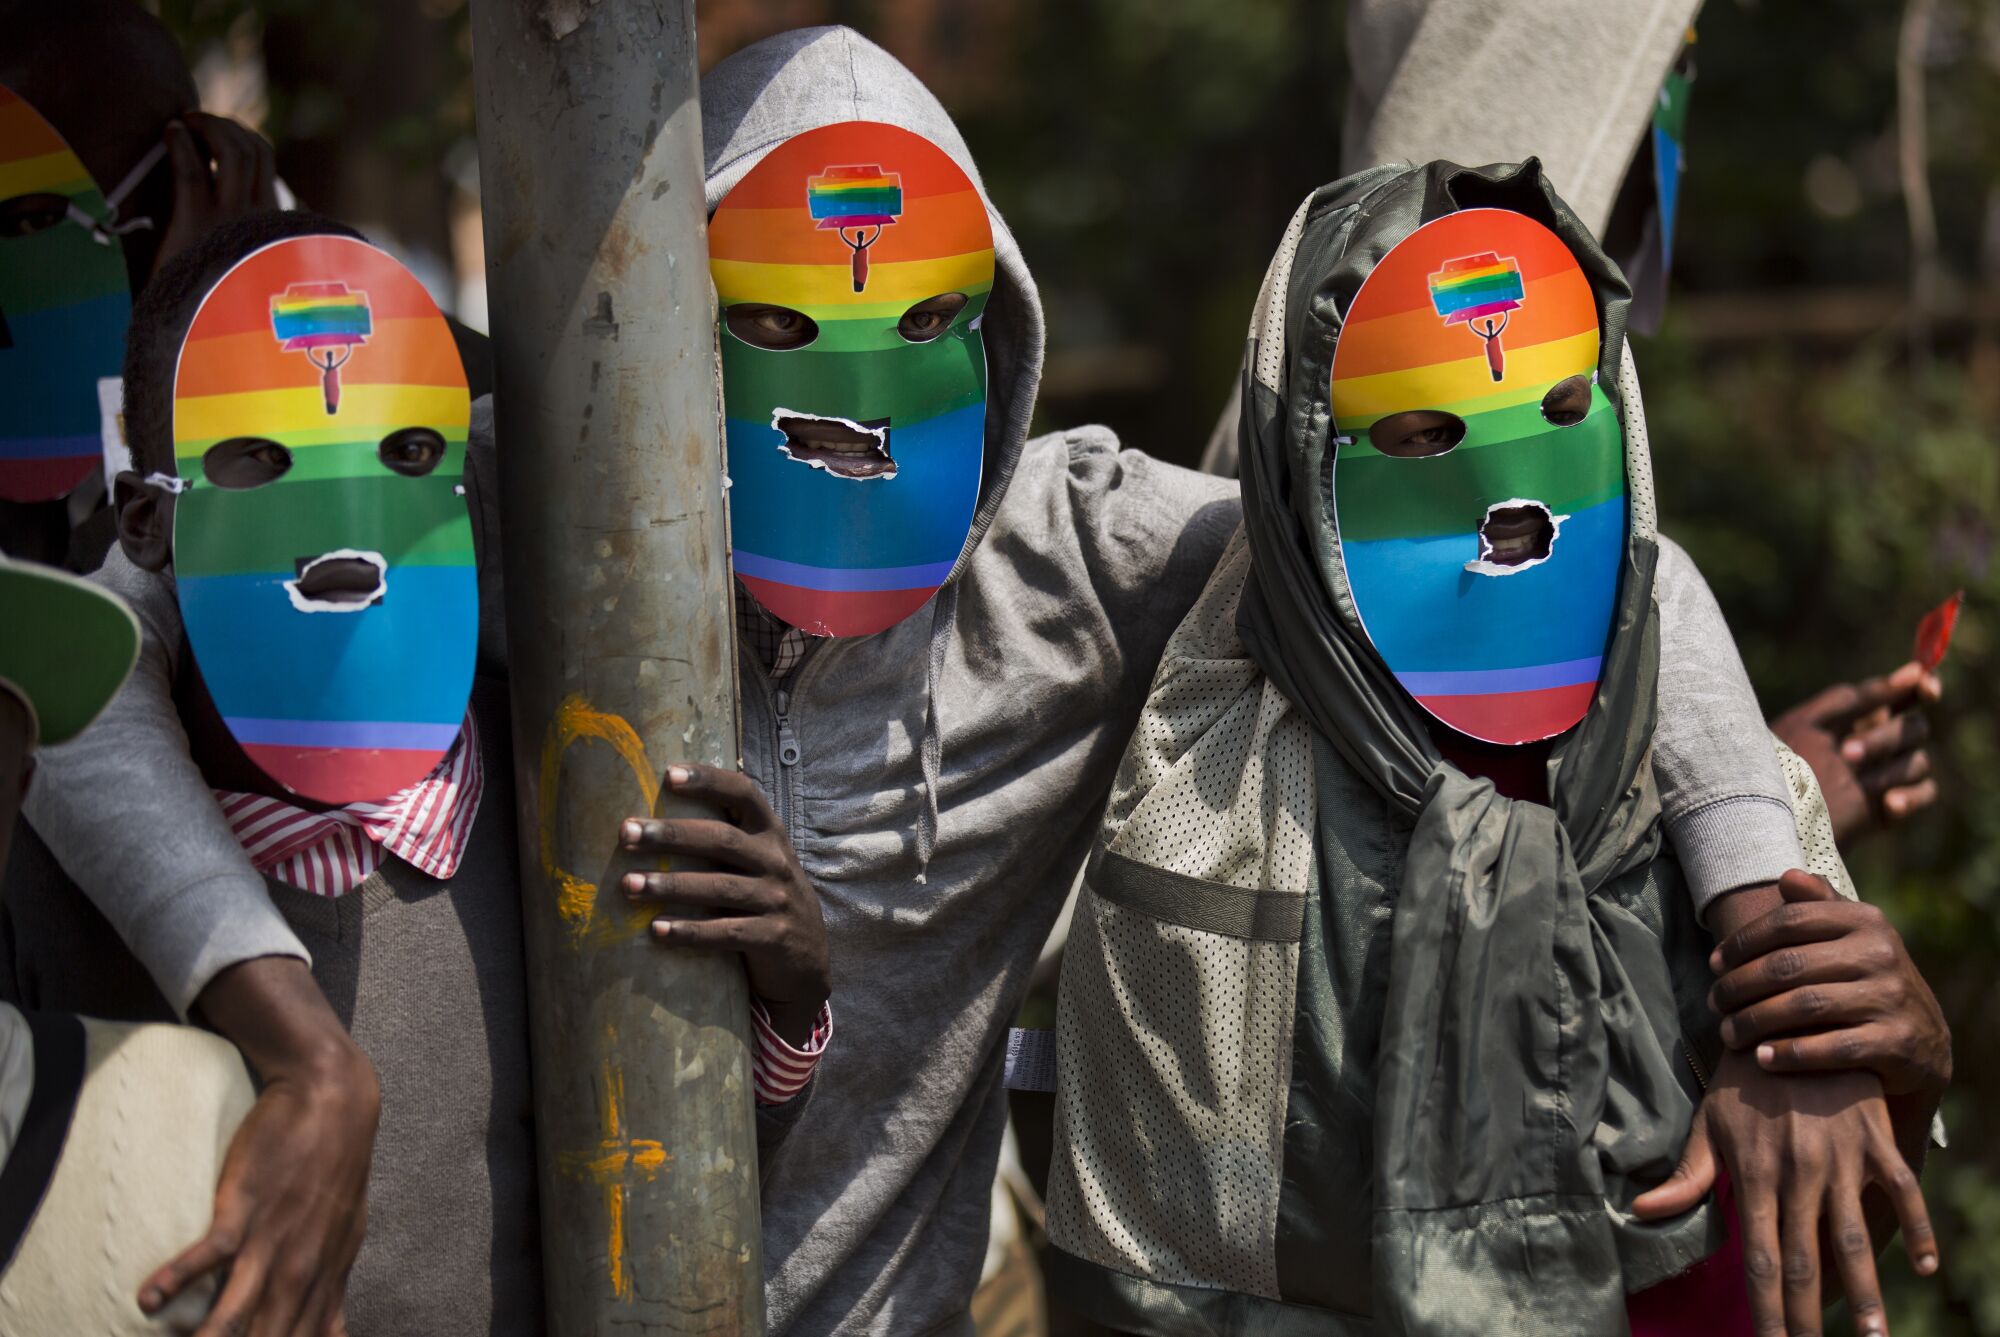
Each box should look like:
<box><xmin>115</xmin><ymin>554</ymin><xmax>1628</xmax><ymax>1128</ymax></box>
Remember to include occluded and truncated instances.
<box><xmin>1632</xmin><ymin>873</ymin><xmax>1938</xmax><ymax>1335</ymax></box>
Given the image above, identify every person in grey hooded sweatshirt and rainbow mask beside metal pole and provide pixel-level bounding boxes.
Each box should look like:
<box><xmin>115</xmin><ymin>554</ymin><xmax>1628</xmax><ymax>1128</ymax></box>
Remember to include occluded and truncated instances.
<box><xmin>15</xmin><ymin>28</ymin><xmax>1920</xmax><ymax>1333</ymax></box>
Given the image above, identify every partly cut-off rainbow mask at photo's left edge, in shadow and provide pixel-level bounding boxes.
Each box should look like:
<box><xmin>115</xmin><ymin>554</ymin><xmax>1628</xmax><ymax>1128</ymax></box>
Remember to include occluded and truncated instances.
<box><xmin>0</xmin><ymin>88</ymin><xmax>132</xmax><ymax>502</ymax></box>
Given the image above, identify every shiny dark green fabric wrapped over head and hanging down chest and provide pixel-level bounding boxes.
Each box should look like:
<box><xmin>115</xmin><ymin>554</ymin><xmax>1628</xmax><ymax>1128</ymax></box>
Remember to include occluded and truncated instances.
<box><xmin>1238</xmin><ymin>160</ymin><xmax>1706</xmax><ymax>1333</ymax></box>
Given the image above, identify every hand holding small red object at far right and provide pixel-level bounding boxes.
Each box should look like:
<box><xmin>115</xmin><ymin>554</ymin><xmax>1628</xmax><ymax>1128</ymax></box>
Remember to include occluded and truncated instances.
<box><xmin>1770</xmin><ymin>660</ymin><xmax>1944</xmax><ymax>845</ymax></box>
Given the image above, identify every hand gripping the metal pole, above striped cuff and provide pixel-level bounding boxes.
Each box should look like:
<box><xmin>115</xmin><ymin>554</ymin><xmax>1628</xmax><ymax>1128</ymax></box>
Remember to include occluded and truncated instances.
<box><xmin>618</xmin><ymin>763</ymin><xmax>830</xmax><ymax>1047</ymax></box>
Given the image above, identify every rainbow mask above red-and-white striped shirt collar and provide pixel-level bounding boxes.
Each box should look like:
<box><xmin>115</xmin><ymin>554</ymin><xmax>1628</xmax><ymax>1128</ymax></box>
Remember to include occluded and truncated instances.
<box><xmin>174</xmin><ymin>236</ymin><xmax>480</xmax><ymax>803</ymax></box>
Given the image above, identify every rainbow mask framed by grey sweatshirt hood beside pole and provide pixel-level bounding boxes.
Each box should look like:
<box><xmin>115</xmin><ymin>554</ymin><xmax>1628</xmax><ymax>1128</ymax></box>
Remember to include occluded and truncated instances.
<box><xmin>708</xmin><ymin>120</ymin><xmax>994</xmax><ymax>636</ymax></box>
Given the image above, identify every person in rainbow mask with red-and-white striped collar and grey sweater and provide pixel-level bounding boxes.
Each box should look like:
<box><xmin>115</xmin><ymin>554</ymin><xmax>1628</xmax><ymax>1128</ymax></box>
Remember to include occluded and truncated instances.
<box><xmin>8</xmin><ymin>212</ymin><xmax>830</xmax><ymax>1337</ymax></box>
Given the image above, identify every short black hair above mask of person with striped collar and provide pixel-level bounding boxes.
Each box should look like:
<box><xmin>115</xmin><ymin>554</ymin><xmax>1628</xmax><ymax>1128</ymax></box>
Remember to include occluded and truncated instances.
<box><xmin>124</xmin><ymin>208</ymin><xmax>366</xmax><ymax>474</ymax></box>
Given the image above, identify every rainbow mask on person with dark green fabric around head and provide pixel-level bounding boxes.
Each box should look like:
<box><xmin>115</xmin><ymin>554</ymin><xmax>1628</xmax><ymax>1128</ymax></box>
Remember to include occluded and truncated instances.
<box><xmin>1332</xmin><ymin>208</ymin><xmax>1626</xmax><ymax>743</ymax></box>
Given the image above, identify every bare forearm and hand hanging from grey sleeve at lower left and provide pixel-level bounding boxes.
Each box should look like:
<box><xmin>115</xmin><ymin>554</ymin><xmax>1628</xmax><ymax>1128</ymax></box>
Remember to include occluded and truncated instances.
<box><xmin>140</xmin><ymin>957</ymin><xmax>382</xmax><ymax>1337</ymax></box>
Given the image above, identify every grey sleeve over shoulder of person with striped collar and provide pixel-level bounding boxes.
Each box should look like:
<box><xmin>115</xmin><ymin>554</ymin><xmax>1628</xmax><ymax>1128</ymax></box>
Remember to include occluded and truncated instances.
<box><xmin>22</xmin><ymin>546</ymin><xmax>310</xmax><ymax>1017</ymax></box>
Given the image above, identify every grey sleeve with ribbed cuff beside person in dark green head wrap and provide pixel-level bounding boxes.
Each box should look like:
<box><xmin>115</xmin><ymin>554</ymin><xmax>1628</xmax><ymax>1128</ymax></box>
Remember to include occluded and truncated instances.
<box><xmin>1654</xmin><ymin>536</ymin><xmax>1806</xmax><ymax>915</ymax></box>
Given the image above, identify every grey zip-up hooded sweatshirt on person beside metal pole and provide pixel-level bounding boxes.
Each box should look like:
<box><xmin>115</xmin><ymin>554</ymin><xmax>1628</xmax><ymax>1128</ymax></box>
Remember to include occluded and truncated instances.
<box><xmin>15</xmin><ymin>28</ymin><xmax>1798</xmax><ymax>1337</ymax></box>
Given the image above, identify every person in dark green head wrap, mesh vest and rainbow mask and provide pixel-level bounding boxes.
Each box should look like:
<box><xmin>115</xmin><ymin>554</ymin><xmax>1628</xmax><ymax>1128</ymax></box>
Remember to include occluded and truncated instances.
<box><xmin>1048</xmin><ymin>160</ymin><xmax>1938</xmax><ymax>1337</ymax></box>
